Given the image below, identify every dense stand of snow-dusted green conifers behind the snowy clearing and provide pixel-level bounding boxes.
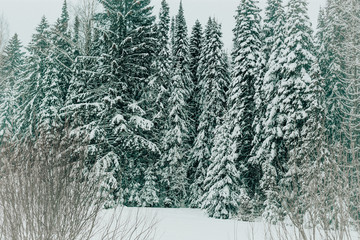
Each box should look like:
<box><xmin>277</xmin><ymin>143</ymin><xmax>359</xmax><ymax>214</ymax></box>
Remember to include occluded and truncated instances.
<box><xmin>0</xmin><ymin>0</ymin><xmax>360</xmax><ymax>232</ymax></box>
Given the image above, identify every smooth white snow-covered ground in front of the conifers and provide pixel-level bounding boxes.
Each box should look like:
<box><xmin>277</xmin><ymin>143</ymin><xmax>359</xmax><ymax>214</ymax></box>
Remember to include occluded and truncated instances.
<box><xmin>95</xmin><ymin>208</ymin><xmax>358</xmax><ymax>240</ymax></box>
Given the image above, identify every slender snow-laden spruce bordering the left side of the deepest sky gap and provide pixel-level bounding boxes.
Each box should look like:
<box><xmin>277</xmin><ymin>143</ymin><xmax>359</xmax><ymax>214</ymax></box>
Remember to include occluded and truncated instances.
<box><xmin>189</xmin><ymin>19</ymin><xmax>230</xmax><ymax>207</ymax></box>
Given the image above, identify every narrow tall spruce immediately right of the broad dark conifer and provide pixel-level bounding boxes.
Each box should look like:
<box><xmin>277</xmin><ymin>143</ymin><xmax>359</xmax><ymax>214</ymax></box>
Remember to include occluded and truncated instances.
<box><xmin>141</xmin><ymin>0</ymin><xmax>171</xmax><ymax>206</ymax></box>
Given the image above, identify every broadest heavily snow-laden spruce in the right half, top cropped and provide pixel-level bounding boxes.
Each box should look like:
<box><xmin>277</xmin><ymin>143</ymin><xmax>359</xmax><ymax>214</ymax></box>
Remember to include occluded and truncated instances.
<box><xmin>262</xmin><ymin>0</ymin><xmax>322</xmax><ymax>221</ymax></box>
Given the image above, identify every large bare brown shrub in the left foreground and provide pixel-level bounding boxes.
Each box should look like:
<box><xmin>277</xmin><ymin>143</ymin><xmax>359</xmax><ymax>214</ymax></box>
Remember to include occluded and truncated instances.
<box><xmin>0</xmin><ymin>131</ymin><xmax>154</xmax><ymax>240</ymax></box>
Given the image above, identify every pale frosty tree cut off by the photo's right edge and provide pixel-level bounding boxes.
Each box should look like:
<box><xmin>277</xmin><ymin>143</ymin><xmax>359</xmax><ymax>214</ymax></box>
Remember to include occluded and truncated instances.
<box><xmin>334</xmin><ymin>0</ymin><xmax>360</xmax><ymax>223</ymax></box>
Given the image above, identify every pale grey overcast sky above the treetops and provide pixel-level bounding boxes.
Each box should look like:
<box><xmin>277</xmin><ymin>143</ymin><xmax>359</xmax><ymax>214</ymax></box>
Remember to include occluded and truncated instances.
<box><xmin>0</xmin><ymin>0</ymin><xmax>326</xmax><ymax>50</ymax></box>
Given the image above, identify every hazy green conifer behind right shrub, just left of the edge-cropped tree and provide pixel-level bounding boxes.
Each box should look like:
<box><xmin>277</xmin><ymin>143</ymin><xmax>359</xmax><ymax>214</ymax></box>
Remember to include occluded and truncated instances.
<box><xmin>317</xmin><ymin>0</ymin><xmax>357</xmax><ymax>154</ymax></box>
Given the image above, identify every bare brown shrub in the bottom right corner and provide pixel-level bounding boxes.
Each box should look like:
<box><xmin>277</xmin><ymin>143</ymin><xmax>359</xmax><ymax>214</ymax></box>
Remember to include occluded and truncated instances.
<box><xmin>271</xmin><ymin>142</ymin><xmax>360</xmax><ymax>240</ymax></box>
